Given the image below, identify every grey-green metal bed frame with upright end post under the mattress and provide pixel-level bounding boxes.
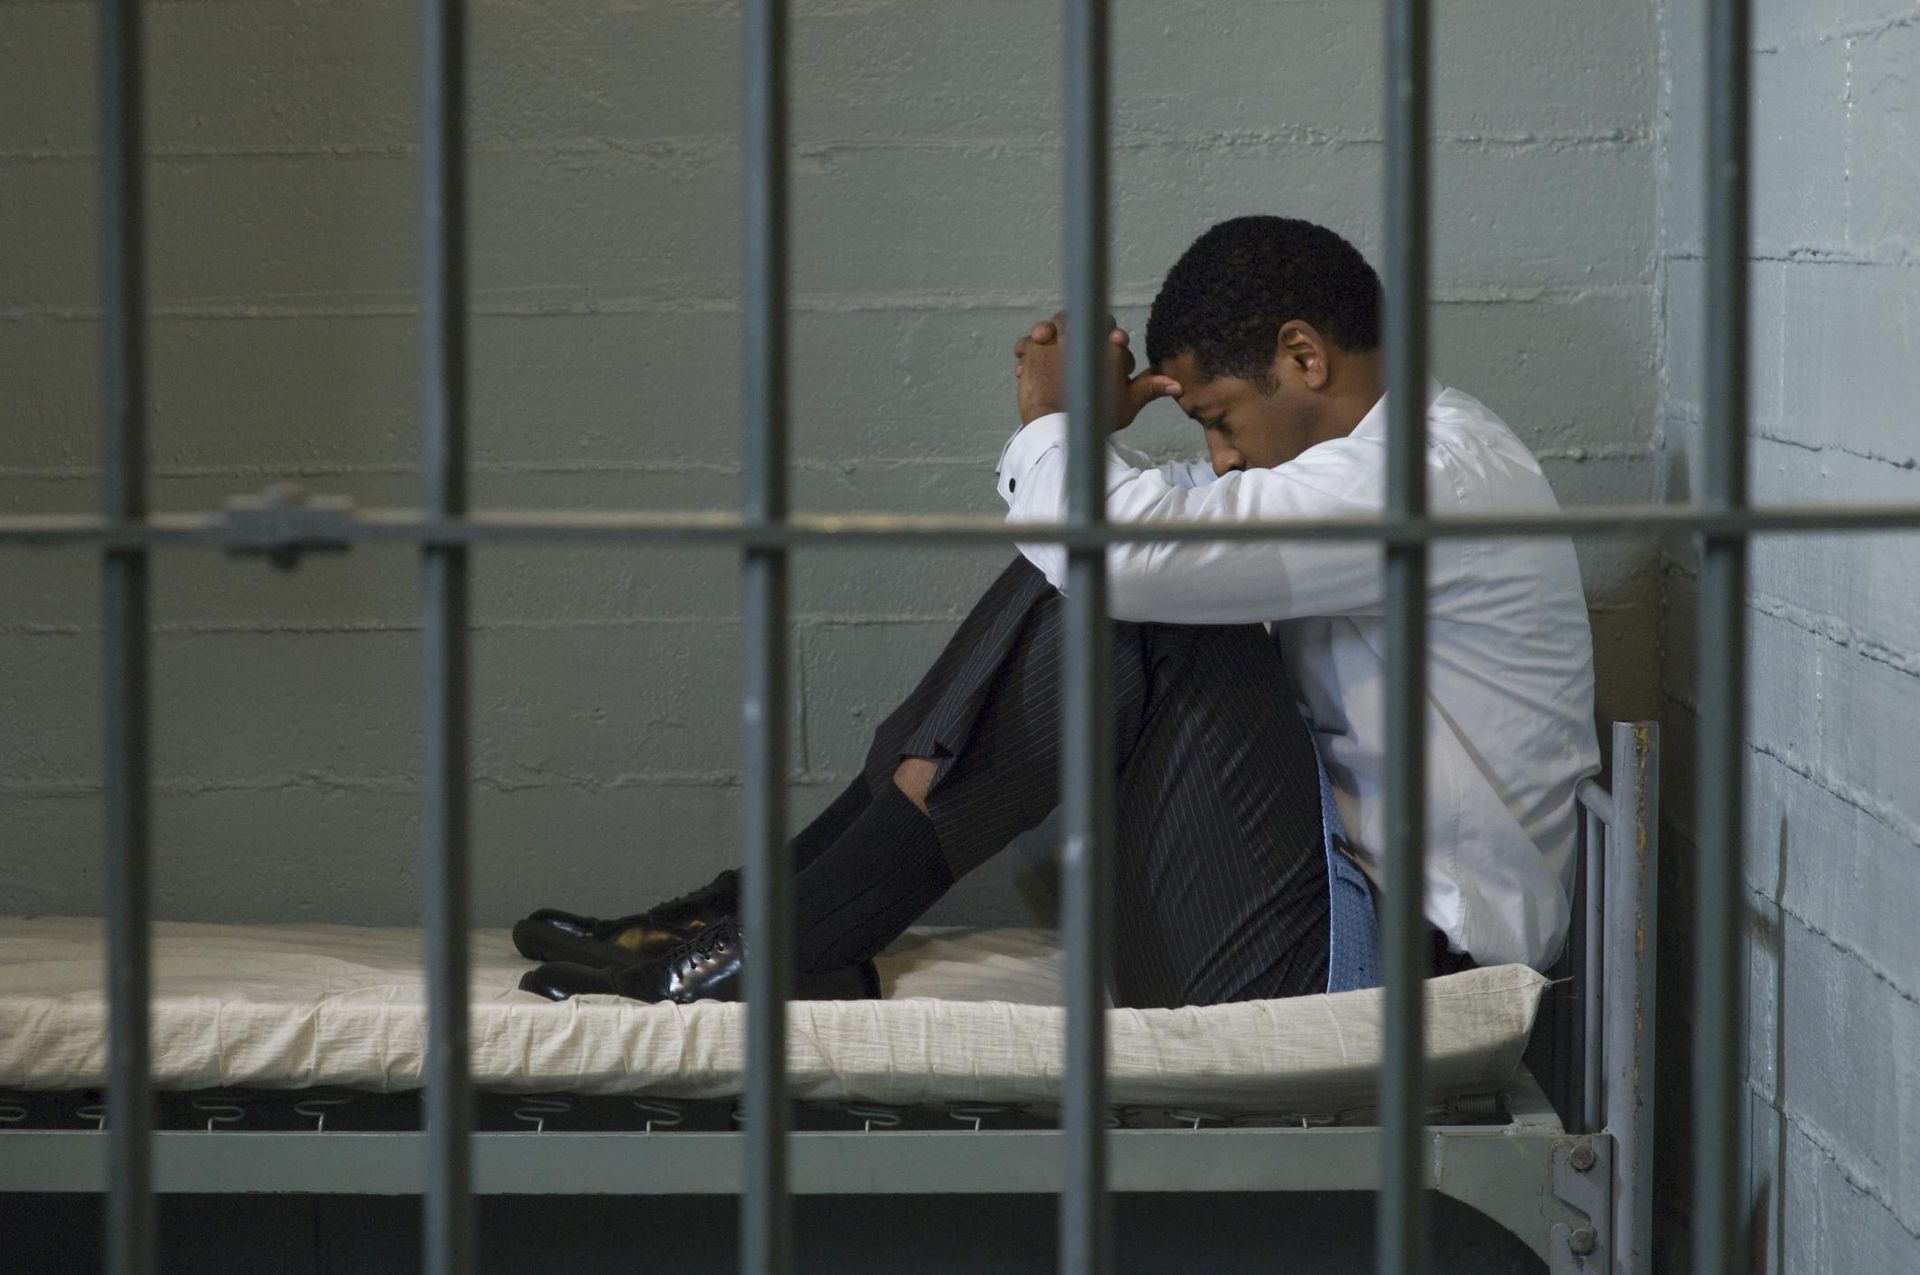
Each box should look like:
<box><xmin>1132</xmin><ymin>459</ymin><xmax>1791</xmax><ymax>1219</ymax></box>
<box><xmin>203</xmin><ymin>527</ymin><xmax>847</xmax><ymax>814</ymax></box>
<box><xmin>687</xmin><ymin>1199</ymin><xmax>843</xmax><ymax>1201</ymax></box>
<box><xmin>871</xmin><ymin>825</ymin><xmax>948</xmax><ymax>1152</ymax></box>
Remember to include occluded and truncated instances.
<box><xmin>0</xmin><ymin>722</ymin><xmax>1659</xmax><ymax>1275</ymax></box>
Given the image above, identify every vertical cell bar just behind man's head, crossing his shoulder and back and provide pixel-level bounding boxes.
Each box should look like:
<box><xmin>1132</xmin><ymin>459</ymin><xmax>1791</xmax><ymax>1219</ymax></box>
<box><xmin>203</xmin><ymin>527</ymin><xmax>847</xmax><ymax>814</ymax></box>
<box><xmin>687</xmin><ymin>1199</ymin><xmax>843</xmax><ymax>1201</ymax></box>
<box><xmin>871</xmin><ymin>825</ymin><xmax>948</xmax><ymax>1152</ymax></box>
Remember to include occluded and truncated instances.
<box><xmin>1375</xmin><ymin>0</ymin><xmax>1430</xmax><ymax>1275</ymax></box>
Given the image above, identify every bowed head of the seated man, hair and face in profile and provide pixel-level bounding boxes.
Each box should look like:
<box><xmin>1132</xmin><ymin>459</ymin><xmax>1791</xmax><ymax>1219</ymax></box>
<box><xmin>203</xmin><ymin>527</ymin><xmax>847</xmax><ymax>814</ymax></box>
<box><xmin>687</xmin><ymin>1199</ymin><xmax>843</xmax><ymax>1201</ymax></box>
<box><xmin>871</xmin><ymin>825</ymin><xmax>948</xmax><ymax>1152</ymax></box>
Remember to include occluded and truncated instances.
<box><xmin>1146</xmin><ymin>217</ymin><xmax>1380</xmax><ymax>474</ymax></box>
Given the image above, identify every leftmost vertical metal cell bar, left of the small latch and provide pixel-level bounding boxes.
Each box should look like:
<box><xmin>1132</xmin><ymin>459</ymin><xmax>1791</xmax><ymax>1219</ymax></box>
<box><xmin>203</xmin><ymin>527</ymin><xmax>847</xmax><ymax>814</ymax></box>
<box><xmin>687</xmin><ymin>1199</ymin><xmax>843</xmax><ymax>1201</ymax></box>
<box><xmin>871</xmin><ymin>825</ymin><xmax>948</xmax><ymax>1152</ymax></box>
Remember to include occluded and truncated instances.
<box><xmin>100</xmin><ymin>0</ymin><xmax>154</xmax><ymax>1275</ymax></box>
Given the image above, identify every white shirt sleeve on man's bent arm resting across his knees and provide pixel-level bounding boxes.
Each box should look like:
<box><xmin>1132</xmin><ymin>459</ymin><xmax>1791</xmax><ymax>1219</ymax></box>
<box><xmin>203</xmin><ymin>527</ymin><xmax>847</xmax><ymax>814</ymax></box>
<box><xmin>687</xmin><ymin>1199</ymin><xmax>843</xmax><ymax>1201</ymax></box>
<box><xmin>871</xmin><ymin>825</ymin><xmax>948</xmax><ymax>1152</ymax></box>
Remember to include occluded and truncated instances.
<box><xmin>998</xmin><ymin>413</ymin><xmax>1413</xmax><ymax>624</ymax></box>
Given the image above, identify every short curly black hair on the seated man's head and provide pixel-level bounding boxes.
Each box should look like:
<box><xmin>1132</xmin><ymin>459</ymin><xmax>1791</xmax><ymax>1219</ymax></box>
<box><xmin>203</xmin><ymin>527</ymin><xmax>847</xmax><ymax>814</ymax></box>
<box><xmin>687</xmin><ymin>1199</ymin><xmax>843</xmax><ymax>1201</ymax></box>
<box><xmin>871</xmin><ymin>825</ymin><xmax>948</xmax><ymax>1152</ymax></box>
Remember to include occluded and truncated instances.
<box><xmin>1146</xmin><ymin>217</ymin><xmax>1380</xmax><ymax>384</ymax></box>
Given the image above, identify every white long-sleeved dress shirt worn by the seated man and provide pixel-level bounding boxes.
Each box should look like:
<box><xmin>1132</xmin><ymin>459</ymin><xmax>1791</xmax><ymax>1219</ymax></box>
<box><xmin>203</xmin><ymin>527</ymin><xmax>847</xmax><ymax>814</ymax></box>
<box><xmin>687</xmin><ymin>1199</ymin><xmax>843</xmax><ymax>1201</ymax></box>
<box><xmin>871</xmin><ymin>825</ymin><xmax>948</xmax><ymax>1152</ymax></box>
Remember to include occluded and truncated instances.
<box><xmin>998</xmin><ymin>382</ymin><xmax>1599</xmax><ymax>970</ymax></box>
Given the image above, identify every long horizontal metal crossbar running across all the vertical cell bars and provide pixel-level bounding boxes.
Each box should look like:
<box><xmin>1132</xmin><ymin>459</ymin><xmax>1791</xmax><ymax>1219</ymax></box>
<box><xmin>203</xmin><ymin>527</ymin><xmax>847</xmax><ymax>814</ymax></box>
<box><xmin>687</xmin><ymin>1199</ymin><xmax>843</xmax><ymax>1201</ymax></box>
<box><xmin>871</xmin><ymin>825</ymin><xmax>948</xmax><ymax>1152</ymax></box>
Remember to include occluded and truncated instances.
<box><xmin>0</xmin><ymin>505</ymin><xmax>1920</xmax><ymax>549</ymax></box>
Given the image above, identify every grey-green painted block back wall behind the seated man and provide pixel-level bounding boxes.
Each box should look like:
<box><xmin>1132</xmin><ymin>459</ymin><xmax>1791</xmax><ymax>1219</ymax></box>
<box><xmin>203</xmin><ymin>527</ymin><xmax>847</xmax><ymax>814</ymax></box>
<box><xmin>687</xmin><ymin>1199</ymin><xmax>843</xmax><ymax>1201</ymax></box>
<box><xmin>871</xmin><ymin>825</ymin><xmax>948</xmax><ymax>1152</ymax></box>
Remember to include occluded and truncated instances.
<box><xmin>0</xmin><ymin>0</ymin><xmax>1659</xmax><ymax>937</ymax></box>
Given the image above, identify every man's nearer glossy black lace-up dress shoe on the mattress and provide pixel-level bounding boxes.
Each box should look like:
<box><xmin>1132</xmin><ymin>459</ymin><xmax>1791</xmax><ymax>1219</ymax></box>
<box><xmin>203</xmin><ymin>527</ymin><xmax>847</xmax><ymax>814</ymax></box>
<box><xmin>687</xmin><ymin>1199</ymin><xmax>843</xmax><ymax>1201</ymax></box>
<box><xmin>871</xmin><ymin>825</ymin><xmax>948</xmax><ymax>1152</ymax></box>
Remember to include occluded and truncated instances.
<box><xmin>520</xmin><ymin>918</ymin><xmax>879</xmax><ymax>1004</ymax></box>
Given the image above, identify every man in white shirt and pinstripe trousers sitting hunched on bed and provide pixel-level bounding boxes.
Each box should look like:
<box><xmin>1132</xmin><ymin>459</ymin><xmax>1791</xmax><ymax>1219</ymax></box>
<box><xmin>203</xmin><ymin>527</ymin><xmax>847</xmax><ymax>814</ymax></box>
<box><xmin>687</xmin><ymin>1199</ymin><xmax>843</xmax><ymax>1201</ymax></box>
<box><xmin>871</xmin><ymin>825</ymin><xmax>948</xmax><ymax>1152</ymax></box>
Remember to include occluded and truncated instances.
<box><xmin>515</xmin><ymin>217</ymin><xmax>1599</xmax><ymax>1006</ymax></box>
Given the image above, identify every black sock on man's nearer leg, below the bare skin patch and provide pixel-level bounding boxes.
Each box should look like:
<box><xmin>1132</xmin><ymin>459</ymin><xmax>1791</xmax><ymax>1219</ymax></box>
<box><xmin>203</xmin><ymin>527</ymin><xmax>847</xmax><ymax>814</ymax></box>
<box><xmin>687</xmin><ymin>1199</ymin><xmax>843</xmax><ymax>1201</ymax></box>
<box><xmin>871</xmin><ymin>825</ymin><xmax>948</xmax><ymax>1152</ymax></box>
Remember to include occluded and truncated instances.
<box><xmin>793</xmin><ymin>780</ymin><xmax>954</xmax><ymax>974</ymax></box>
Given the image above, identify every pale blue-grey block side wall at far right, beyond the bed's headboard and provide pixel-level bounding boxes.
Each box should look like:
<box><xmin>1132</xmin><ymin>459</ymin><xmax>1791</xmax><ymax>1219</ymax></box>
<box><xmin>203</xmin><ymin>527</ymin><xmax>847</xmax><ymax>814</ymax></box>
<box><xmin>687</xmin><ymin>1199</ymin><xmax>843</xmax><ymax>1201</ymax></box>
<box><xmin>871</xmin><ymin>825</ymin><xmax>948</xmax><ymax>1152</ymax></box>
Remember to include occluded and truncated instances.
<box><xmin>1659</xmin><ymin>0</ymin><xmax>1920</xmax><ymax>1275</ymax></box>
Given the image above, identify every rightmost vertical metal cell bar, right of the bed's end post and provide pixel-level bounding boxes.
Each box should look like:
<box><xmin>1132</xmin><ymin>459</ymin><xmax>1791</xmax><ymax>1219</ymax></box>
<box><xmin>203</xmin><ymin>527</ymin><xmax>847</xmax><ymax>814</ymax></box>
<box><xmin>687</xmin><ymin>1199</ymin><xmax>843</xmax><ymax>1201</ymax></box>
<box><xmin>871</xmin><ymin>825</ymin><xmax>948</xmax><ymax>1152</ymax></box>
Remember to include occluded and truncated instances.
<box><xmin>1693</xmin><ymin>0</ymin><xmax>1751</xmax><ymax>1275</ymax></box>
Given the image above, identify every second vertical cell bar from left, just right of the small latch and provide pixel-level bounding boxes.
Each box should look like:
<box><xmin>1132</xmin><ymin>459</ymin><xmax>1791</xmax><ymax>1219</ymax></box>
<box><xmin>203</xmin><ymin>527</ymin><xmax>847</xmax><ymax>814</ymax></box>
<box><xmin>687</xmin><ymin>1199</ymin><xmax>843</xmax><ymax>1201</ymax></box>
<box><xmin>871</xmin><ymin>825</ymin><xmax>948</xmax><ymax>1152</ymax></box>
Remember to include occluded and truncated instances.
<box><xmin>420</xmin><ymin>0</ymin><xmax>474</xmax><ymax>1275</ymax></box>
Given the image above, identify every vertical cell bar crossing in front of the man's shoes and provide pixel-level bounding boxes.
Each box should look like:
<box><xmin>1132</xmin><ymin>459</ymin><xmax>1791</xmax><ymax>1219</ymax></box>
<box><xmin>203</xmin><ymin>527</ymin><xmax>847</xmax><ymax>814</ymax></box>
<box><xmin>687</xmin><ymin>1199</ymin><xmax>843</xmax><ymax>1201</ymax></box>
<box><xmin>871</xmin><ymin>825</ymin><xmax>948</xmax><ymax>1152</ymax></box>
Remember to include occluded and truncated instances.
<box><xmin>739</xmin><ymin>0</ymin><xmax>793</xmax><ymax>1275</ymax></box>
